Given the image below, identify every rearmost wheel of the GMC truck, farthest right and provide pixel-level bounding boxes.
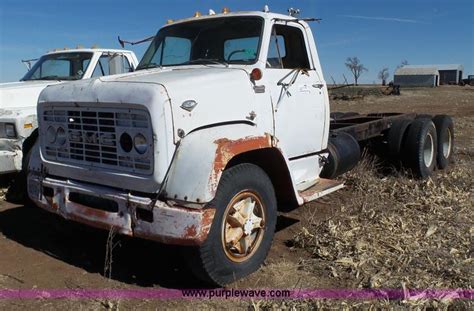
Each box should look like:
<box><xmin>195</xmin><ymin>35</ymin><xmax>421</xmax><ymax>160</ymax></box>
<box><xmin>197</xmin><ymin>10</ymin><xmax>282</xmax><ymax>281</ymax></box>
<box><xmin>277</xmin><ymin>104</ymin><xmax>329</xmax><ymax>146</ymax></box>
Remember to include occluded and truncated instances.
<box><xmin>433</xmin><ymin>115</ymin><xmax>454</xmax><ymax>169</ymax></box>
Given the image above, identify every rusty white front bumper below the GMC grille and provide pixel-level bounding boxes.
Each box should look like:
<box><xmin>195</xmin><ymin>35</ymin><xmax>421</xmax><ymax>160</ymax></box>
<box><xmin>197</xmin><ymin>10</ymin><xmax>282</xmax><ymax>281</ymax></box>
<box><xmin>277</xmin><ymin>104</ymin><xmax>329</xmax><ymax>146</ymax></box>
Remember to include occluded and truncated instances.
<box><xmin>28</xmin><ymin>173</ymin><xmax>215</xmax><ymax>245</ymax></box>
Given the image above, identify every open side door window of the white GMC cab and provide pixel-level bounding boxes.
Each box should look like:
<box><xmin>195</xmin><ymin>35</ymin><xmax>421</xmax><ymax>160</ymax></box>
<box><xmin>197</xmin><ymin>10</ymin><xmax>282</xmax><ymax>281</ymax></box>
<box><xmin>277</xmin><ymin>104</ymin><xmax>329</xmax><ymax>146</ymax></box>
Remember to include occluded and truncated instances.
<box><xmin>267</xmin><ymin>25</ymin><xmax>309</xmax><ymax>69</ymax></box>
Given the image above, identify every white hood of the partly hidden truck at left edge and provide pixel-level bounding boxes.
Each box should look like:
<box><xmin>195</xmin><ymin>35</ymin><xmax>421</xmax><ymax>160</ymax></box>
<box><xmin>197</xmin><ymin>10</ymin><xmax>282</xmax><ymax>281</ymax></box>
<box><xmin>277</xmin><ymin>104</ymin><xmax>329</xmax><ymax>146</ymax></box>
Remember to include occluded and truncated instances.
<box><xmin>0</xmin><ymin>81</ymin><xmax>60</xmax><ymax>113</ymax></box>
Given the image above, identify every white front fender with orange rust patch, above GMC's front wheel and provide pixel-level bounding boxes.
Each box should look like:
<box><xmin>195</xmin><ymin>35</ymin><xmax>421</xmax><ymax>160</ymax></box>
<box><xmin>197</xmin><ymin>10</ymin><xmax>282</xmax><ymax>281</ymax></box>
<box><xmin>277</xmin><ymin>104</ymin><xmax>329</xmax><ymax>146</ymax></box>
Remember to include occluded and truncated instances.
<box><xmin>163</xmin><ymin>124</ymin><xmax>272</xmax><ymax>204</ymax></box>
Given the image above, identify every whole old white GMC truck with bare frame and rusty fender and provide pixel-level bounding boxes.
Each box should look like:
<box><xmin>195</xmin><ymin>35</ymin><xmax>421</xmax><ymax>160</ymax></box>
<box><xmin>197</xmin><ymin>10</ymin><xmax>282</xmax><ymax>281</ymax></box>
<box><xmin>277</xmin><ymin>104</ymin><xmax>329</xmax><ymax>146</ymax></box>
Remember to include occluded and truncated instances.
<box><xmin>28</xmin><ymin>9</ymin><xmax>453</xmax><ymax>285</ymax></box>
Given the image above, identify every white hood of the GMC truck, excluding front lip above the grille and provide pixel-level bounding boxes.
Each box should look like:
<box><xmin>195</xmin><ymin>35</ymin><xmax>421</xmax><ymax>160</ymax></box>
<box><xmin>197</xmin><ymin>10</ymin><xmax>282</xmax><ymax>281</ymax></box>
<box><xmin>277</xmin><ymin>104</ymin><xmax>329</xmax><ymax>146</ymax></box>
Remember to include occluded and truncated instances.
<box><xmin>101</xmin><ymin>66</ymin><xmax>255</xmax><ymax>142</ymax></box>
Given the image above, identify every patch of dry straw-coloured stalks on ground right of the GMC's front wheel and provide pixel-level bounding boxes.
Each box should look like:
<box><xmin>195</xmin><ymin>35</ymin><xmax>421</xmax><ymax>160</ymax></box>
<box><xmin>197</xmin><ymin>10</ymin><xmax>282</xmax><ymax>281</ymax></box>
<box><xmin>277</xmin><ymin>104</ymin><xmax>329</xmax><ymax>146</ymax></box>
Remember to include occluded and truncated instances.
<box><xmin>260</xmin><ymin>153</ymin><xmax>474</xmax><ymax>307</ymax></box>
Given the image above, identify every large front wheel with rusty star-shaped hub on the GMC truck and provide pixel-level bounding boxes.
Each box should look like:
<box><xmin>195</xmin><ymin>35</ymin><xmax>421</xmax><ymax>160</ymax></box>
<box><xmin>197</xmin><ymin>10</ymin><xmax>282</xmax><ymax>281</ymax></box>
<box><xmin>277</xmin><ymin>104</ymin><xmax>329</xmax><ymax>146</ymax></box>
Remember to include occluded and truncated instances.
<box><xmin>187</xmin><ymin>164</ymin><xmax>277</xmax><ymax>285</ymax></box>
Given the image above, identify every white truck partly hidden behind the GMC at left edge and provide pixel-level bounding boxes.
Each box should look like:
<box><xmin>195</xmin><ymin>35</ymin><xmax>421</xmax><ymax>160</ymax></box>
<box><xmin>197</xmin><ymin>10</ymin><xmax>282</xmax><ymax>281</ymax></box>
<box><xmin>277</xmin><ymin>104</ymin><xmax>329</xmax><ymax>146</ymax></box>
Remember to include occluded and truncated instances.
<box><xmin>0</xmin><ymin>48</ymin><xmax>138</xmax><ymax>175</ymax></box>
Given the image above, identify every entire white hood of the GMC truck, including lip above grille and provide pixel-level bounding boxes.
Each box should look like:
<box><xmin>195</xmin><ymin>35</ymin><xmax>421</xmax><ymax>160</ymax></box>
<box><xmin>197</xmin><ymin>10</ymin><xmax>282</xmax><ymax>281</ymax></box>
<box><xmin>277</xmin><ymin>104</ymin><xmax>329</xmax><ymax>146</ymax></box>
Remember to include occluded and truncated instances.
<box><xmin>40</xmin><ymin>66</ymin><xmax>255</xmax><ymax>142</ymax></box>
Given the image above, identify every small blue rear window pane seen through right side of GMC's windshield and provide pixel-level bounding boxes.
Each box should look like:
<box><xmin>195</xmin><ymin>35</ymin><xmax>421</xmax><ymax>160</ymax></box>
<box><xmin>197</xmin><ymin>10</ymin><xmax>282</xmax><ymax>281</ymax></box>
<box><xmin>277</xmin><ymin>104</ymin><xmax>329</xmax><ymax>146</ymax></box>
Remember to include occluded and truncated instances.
<box><xmin>224</xmin><ymin>37</ymin><xmax>260</xmax><ymax>61</ymax></box>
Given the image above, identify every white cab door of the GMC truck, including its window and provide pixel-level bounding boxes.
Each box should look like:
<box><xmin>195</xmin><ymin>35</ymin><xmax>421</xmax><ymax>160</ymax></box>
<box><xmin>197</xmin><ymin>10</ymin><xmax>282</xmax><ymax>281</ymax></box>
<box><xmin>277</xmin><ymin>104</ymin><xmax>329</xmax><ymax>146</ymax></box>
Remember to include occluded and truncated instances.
<box><xmin>265</xmin><ymin>22</ymin><xmax>326</xmax><ymax>190</ymax></box>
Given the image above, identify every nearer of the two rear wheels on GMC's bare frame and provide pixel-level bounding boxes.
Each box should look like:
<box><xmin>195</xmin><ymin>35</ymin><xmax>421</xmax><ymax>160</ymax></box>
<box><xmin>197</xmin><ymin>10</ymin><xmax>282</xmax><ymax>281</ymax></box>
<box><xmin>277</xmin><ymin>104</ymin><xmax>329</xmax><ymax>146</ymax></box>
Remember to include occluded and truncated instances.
<box><xmin>403</xmin><ymin>119</ymin><xmax>437</xmax><ymax>179</ymax></box>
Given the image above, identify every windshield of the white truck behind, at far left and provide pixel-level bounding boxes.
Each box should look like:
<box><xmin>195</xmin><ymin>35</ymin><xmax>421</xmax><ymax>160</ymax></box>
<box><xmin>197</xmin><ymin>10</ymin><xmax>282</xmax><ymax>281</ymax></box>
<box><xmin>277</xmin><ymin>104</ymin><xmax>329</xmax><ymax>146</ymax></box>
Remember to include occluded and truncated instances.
<box><xmin>21</xmin><ymin>53</ymin><xmax>93</xmax><ymax>81</ymax></box>
